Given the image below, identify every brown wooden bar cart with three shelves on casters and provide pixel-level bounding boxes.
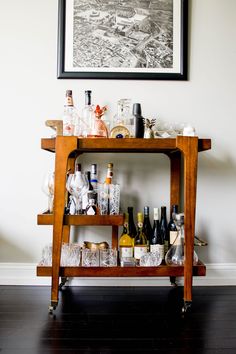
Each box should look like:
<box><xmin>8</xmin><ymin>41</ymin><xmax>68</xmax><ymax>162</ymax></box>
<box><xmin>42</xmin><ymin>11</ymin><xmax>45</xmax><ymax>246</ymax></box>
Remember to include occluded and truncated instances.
<box><xmin>37</xmin><ymin>136</ymin><xmax>211</xmax><ymax>312</ymax></box>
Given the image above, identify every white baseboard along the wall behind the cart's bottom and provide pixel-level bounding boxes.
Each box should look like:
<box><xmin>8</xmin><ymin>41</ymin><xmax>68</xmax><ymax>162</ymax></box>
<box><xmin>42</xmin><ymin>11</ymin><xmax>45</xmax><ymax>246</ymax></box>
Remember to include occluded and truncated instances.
<box><xmin>0</xmin><ymin>263</ymin><xmax>236</xmax><ymax>286</ymax></box>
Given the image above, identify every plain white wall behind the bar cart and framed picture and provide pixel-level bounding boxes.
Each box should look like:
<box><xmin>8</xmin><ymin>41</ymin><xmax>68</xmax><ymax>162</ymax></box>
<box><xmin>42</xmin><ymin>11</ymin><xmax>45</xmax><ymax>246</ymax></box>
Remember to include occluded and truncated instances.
<box><xmin>0</xmin><ymin>0</ymin><xmax>236</xmax><ymax>282</ymax></box>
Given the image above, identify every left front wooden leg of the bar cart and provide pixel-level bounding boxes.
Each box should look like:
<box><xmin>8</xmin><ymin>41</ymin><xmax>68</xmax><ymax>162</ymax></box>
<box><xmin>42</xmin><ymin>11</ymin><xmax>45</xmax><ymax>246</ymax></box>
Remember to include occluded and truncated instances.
<box><xmin>49</xmin><ymin>136</ymin><xmax>77</xmax><ymax>313</ymax></box>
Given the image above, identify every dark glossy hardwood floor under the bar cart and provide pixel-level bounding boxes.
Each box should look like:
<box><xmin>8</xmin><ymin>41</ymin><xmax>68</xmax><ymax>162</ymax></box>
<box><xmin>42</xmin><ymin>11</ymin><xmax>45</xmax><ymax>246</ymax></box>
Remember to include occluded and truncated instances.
<box><xmin>0</xmin><ymin>286</ymin><xmax>236</xmax><ymax>354</ymax></box>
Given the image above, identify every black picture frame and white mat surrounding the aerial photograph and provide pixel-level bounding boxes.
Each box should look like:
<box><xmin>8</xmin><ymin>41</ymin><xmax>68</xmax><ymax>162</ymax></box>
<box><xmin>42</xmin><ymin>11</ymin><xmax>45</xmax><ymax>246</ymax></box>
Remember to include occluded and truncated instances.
<box><xmin>57</xmin><ymin>0</ymin><xmax>188</xmax><ymax>80</ymax></box>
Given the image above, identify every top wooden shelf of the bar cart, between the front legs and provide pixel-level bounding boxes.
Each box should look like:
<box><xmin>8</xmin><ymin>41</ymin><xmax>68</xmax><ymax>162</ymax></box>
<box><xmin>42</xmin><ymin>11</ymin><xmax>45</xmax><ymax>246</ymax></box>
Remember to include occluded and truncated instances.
<box><xmin>41</xmin><ymin>136</ymin><xmax>211</xmax><ymax>153</ymax></box>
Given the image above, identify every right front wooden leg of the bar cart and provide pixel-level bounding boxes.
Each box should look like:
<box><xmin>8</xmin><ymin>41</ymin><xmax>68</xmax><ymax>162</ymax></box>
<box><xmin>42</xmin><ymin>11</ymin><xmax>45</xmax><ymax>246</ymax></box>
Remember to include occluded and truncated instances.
<box><xmin>177</xmin><ymin>136</ymin><xmax>198</xmax><ymax>306</ymax></box>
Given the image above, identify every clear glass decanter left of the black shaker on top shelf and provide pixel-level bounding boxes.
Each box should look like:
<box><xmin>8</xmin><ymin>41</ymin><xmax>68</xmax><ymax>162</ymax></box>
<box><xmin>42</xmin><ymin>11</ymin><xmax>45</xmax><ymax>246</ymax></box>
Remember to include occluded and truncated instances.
<box><xmin>111</xmin><ymin>98</ymin><xmax>134</xmax><ymax>138</ymax></box>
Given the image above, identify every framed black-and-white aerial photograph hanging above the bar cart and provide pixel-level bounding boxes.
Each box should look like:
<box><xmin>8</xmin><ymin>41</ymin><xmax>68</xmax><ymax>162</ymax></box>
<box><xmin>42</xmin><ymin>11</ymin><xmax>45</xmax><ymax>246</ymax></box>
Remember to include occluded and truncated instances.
<box><xmin>57</xmin><ymin>0</ymin><xmax>188</xmax><ymax>80</ymax></box>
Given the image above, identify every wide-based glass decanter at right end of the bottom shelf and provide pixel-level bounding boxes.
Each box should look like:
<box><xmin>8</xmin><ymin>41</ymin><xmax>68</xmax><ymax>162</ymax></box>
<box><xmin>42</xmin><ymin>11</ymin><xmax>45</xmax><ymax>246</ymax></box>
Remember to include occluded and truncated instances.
<box><xmin>165</xmin><ymin>213</ymin><xmax>198</xmax><ymax>266</ymax></box>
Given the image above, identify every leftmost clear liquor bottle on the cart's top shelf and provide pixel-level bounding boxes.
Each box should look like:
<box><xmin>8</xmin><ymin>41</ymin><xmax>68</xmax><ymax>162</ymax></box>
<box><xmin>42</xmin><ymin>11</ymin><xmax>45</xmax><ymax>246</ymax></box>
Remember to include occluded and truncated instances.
<box><xmin>63</xmin><ymin>90</ymin><xmax>78</xmax><ymax>136</ymax></box>
